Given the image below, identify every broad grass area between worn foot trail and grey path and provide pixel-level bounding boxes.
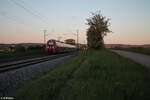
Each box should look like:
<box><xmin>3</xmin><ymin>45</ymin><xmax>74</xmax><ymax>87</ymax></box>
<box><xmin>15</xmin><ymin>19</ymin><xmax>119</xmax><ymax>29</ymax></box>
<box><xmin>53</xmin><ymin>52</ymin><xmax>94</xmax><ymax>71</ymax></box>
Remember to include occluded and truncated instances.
<box><xmin>59</xmin><ymin>50</ymin><xmax>150</xmax><ymax>100</ymax></box>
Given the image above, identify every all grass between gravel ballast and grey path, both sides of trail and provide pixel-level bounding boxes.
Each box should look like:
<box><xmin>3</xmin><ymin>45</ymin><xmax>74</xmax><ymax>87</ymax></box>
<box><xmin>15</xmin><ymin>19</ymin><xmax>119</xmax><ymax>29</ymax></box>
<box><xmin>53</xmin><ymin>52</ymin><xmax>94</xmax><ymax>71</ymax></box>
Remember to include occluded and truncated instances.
<box><xmin>12</xmin><ymin>50</ymin><xmax>150</xmax><ymax>100</ymax></box>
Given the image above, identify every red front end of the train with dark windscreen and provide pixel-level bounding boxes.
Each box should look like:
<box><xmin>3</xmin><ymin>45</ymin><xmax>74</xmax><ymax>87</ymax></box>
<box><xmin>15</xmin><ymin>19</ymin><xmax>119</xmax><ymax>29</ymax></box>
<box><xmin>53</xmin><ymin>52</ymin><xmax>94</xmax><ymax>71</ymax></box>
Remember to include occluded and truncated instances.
<box><xmin>45</xmin><ymin>40</ymin><xmax>56</xmax><ymax>54</ymax></box>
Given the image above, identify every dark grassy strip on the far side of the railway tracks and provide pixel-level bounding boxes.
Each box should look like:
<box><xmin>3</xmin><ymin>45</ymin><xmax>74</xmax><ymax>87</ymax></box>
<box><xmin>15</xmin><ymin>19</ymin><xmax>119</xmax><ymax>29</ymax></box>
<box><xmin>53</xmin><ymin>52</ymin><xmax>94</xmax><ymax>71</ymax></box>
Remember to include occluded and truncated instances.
<box><xmin>0</xmin><ymin>50</ymin><xmax>46</xmax><ymax>61</ymax></box>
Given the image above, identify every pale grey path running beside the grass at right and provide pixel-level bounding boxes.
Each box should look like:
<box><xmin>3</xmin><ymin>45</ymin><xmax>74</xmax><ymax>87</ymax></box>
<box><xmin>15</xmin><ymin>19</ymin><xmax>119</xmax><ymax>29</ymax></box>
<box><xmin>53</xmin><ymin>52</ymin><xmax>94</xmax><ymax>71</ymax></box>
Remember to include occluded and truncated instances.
<box><xmin>112</xmin><ymin>50</ymin><xmax>150</xmax><ymax>68</ymax></box>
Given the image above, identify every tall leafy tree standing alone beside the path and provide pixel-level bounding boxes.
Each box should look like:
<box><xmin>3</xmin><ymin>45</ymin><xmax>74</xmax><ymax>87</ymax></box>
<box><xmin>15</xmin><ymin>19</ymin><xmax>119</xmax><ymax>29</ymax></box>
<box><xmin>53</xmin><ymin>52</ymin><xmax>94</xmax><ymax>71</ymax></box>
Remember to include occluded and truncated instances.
<box><xmin>87</xmin><ymin>12</ymin><xmax>111</xmax><ymax>49</ymax></box>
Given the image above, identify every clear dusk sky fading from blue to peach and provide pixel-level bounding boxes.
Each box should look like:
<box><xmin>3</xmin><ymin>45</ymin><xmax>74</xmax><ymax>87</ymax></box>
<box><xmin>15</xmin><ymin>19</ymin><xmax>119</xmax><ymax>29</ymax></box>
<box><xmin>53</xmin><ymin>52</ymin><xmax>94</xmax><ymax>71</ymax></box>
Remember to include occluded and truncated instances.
<box><xmin>0</xmin><ymin>0</ymin><xmax>150</xmax><ymax>45</ymax></box>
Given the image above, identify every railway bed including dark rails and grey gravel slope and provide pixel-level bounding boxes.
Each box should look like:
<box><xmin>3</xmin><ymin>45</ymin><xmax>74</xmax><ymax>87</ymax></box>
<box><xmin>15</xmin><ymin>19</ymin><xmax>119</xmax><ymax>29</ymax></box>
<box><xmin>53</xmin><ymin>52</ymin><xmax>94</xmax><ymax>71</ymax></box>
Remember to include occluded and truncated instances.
<box><xmin>0</xmin><ymin>53</ymin><xmax>76</xmax><ymax>97</ymax></box>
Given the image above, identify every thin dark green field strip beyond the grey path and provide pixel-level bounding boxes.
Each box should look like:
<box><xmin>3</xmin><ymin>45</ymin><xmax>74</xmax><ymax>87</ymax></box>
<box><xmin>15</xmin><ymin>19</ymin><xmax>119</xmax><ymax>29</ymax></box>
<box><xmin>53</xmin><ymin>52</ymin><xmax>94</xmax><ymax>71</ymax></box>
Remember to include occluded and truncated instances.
<box><xmin>113</xmin><ymin>47</ymin><xmax>150</xmax><ymax>55</ymax></box>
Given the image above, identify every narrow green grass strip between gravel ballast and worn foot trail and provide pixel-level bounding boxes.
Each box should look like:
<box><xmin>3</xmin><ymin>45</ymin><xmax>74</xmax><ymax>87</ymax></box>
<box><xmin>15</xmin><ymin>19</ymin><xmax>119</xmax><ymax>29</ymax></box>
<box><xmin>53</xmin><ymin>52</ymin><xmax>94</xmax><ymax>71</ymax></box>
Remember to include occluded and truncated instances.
<box><xmin>13</xmin><ymin>54</ymin><xmax>84</xmax><ymax>100</ymax></box>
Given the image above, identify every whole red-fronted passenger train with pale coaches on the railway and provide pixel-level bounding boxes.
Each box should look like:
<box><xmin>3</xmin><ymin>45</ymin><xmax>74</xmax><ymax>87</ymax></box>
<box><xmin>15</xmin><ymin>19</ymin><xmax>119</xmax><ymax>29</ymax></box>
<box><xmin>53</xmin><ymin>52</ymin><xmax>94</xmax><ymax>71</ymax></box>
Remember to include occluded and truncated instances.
<box><xmin>45</xmin><ymin>40</ymin><xmax>76</xmax><ymax>54</ymax></box>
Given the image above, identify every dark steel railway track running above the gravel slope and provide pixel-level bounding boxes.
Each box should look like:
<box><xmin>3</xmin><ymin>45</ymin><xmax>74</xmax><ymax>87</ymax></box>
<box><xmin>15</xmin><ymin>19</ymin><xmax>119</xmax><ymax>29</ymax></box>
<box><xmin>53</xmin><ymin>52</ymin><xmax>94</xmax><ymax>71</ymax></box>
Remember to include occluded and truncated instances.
<box><xmin>0</xmin><ymin>53</ymin><xmax>74</xmax><ymax>73</ymax></box>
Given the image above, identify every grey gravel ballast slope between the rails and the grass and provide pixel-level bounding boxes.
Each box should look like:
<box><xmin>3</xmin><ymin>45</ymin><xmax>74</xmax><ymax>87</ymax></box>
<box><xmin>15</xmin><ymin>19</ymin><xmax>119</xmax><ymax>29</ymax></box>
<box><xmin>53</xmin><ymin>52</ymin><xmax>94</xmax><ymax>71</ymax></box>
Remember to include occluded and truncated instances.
<box><xmin>0</xmin><ymin>55</ymin><xmax>73</xmax><ymax>97</ymax></box>
